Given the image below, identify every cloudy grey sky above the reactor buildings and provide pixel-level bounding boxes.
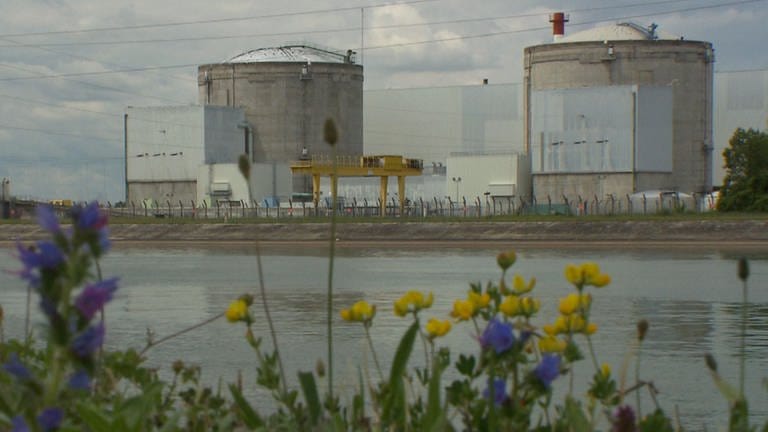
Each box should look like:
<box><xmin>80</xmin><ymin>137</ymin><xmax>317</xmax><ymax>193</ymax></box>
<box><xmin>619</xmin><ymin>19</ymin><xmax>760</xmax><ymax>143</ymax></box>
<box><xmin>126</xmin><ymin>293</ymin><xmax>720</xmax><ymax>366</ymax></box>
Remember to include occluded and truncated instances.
<box><xmin>0</xmin><ymin>0</ymin><xmax>768</xmax><ymax>202</ymax></box>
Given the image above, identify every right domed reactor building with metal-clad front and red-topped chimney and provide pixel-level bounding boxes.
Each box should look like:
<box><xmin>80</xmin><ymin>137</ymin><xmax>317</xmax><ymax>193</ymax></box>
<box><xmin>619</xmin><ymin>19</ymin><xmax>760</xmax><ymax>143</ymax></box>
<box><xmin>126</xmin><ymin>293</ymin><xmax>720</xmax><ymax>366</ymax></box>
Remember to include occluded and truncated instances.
<box><xmin>524</xmin><ymin>13</ymin><xmax>714</xmax><ymax>201</ymax></box>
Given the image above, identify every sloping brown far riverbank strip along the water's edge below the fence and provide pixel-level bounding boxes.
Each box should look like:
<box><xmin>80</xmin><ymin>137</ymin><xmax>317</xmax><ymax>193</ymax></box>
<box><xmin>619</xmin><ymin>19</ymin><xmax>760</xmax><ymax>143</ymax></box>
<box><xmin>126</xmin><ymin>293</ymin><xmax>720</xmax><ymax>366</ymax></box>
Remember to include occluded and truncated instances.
<box><xmin>0</xmin><ymin>220</ymin><xmax>768</xmax><ymax>245</ymax></box>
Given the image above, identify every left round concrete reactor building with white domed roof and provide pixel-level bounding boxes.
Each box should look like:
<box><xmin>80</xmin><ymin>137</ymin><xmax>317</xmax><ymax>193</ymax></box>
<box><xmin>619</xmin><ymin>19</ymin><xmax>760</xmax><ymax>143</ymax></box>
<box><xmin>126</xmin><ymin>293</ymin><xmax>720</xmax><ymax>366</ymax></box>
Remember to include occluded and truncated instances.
<box><xmin>198</xmin><ymin>45</ymin><xmax>363</xmax><ymax>163</ymax></box>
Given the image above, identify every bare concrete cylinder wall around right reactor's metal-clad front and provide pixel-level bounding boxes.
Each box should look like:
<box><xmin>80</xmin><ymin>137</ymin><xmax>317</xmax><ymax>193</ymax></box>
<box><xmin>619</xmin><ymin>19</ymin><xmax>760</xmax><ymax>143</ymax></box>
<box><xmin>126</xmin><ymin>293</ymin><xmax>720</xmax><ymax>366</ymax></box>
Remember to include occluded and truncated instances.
<box><xmin>524</xmin><ymin>40</ymin><xmax>714</xmax><ymax>195</ymax></box>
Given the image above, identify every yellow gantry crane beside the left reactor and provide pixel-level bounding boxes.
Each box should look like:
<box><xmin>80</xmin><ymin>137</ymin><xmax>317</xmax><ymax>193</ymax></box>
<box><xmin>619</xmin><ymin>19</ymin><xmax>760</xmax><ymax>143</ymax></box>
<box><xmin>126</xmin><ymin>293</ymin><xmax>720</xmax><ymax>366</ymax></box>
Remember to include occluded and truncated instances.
<box><xmin>291</xmin><ymin>155</ymin><xmax>424</xmax><ymax>216</ymax></box>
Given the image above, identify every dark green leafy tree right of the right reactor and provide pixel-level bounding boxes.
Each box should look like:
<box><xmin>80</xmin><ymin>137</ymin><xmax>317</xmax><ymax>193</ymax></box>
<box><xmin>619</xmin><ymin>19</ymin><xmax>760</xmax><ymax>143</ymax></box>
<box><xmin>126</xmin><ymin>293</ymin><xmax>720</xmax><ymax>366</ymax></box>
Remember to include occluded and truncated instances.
<box><xmin>717</xmin><ymin>128</ymin><xmax>768</xmax><ymax>211</ymax></box>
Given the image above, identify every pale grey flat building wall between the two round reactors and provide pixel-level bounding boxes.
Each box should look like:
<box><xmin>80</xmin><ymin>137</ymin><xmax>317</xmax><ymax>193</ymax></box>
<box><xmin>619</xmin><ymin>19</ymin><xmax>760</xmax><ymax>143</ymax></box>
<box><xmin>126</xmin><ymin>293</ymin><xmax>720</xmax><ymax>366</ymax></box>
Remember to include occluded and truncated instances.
<box><xmin>364</xmin><ymin>83</ymin><xmax>523</xmax><ymax>166</ymax></box>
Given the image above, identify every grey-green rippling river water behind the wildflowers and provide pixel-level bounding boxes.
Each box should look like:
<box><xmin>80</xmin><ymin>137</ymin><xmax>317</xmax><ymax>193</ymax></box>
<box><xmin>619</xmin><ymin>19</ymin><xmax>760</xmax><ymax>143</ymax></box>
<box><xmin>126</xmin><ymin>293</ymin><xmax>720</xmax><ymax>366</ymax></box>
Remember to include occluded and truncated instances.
<box><xmin>0</xmin><ymin>243</ymin><xmax>768</xmax><ymax>430</ymax></box>
